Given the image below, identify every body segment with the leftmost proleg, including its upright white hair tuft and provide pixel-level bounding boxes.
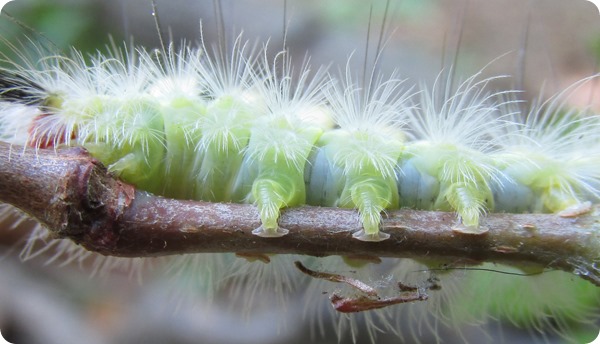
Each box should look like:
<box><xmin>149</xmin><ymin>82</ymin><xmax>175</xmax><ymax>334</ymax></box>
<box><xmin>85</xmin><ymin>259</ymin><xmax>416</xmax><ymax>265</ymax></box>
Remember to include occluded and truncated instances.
<box><xmin>236</xmin><ymin>53</ymin><xmax>331</xmax><ymax>237</ymax></box>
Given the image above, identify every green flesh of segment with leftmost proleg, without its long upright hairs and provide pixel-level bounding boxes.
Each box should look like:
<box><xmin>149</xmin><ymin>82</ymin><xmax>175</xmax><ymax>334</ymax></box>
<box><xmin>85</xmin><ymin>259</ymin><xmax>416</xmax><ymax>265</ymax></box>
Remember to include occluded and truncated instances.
<box><xmin>236</xmin><ymin>115</ymin><xmax>322</xmax><ymax>237</ymax></box>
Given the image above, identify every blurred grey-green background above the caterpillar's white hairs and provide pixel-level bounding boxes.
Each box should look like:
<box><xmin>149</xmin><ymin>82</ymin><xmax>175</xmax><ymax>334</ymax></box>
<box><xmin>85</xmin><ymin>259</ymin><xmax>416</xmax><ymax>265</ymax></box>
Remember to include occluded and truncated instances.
<box><xmin>0</xmin><ymin>0</ymin><xmax>600</xmax><ymax>101</ymax></box>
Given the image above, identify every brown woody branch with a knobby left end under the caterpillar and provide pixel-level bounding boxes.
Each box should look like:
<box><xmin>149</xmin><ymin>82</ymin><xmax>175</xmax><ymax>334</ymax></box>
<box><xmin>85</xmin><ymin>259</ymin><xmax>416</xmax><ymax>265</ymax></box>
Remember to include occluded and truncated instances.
<box><xmin>0</xmin><ymin>142</ymin><xmax>600</xmax><ymax>286</ymax></box>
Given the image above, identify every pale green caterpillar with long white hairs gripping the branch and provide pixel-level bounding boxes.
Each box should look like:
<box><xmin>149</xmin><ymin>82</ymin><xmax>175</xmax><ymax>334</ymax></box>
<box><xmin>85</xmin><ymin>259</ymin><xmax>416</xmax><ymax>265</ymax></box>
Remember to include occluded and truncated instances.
<box><xmin>0</xmin><ymin>0</ymin><xmax>600</xmax><ymax>341</ymax></box>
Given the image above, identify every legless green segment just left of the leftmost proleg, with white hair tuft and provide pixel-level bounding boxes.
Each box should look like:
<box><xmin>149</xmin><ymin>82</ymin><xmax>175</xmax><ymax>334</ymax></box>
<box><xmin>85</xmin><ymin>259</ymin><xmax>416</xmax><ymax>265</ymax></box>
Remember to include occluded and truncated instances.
<box><xmin>193</xmin><ymin>36</ymin><xmax>267</xmax><ymax>202</ymax></box>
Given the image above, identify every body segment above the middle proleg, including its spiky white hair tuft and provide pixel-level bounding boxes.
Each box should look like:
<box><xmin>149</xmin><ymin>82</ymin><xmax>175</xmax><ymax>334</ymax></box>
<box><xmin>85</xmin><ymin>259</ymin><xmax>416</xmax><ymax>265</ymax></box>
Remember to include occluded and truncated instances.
<box><xmin>309</xmin><ymin>70</ymin><xmax>411</xmax><ymax>241</ymax></box>
